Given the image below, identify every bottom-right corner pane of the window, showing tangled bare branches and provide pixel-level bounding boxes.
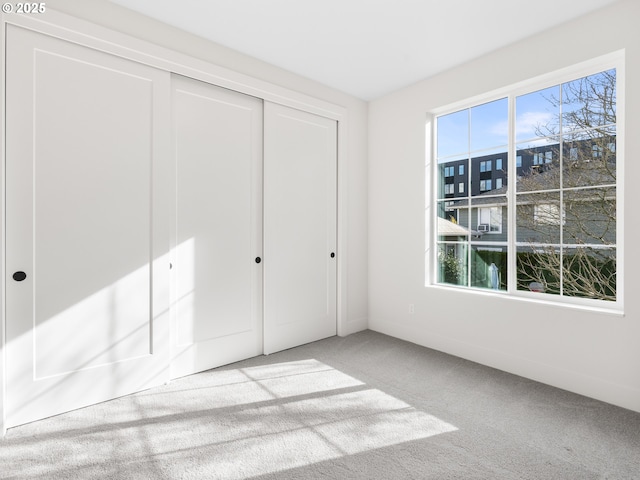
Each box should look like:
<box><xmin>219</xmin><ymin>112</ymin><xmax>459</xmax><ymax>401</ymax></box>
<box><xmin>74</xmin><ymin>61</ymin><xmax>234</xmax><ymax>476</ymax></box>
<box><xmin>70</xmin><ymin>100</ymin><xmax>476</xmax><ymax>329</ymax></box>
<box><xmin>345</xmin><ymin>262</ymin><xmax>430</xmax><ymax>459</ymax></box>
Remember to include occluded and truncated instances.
<box><xmin>562</xmin><ymin>247</ymin><xmax>616</xmax><ymax>301</ymax></box>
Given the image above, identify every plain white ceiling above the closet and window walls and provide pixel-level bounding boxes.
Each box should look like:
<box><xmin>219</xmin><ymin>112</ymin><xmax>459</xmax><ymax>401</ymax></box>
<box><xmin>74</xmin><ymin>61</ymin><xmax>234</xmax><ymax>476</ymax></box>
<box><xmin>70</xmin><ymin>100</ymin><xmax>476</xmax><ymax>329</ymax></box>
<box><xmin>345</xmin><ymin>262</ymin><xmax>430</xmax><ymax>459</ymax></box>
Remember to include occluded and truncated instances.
<box><xmin>110</xmin><ymin>0</ymin><xmax>618</xmax><ymax>100</ymax></box>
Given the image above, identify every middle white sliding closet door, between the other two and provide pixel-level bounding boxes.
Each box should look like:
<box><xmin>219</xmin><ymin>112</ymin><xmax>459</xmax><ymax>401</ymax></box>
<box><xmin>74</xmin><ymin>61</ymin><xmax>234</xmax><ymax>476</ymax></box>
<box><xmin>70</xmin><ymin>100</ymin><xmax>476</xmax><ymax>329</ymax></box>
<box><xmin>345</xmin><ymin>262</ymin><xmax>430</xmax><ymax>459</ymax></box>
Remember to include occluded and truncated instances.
<box><xmin>171</xmin><ymin>76</ymin><xmax>262</xmax><ymax>378</ymax></box>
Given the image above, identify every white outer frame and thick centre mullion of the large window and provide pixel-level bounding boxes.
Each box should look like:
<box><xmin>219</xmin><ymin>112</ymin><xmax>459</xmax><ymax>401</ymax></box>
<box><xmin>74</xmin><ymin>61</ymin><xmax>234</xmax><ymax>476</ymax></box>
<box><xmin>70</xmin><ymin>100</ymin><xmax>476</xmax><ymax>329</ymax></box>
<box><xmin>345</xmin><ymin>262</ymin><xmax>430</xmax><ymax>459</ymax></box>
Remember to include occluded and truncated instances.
<box><xmin>425</xmin><ymin>51</ymin><xmax>626</xmax><ymax>315</ymax></box>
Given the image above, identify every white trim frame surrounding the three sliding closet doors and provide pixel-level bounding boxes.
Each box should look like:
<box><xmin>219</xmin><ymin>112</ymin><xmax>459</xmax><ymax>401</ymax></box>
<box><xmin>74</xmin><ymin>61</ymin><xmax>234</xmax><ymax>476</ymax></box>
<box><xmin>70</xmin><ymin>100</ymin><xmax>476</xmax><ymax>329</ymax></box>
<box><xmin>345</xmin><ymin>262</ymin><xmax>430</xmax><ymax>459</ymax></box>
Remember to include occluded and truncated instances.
<box><xmin>0</xmin><ymin>6</ymin><xmax>350</xmax><ymax>435</ymax></box>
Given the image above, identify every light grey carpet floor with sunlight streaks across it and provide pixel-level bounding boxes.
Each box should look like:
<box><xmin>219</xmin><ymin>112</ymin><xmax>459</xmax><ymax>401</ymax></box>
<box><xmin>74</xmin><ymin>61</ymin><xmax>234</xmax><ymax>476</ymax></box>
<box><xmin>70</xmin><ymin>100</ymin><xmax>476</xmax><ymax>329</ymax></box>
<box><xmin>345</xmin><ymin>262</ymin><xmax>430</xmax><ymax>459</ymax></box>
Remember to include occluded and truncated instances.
<box><xmin>0</xmin><ymin>331</ymin><xmax>640</xmax><ymax>480</ymax></box>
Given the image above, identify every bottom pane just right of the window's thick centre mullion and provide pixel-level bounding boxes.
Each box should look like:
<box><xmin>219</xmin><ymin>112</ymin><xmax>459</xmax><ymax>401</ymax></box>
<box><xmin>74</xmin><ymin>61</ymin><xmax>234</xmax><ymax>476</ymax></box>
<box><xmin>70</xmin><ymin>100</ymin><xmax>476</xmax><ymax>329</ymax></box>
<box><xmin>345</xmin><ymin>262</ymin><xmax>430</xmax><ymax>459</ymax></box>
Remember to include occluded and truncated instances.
<box><xmin>516</xmin><ymin>246</ymin><xmax>560</xmax><ymax>295</ymax></box>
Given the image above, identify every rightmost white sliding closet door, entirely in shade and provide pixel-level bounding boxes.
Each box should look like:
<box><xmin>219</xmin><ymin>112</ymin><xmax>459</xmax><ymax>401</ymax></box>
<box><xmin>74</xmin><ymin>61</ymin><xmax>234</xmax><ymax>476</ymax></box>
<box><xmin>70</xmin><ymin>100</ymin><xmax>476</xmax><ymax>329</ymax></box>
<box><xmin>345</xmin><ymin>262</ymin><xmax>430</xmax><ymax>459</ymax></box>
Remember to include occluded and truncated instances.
<box><xmin>264</xmin><ymin>103</ymin><xmax>338</xmax><ymax>353</ymax></box>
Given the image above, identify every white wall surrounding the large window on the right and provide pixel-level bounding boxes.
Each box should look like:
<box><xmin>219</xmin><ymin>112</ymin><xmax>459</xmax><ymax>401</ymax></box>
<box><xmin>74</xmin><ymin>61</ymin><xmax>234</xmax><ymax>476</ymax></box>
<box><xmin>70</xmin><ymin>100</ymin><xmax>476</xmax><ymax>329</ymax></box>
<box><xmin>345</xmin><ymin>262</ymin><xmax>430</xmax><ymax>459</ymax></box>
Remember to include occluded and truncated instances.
<box><xmin>369</xmin><ymin>0</ymin><xmax>640</xmax><ymax>411</ymax></box>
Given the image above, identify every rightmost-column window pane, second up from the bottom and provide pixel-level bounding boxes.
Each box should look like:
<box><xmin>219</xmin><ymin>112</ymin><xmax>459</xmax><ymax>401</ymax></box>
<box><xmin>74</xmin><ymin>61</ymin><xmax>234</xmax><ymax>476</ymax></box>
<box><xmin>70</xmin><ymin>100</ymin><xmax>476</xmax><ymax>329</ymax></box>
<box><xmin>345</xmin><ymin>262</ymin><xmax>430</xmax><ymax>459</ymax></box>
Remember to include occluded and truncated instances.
<box><xmin>563</xmin><ymin>187</ymin><xmax>616</xmax><ymax>245</ymax></box>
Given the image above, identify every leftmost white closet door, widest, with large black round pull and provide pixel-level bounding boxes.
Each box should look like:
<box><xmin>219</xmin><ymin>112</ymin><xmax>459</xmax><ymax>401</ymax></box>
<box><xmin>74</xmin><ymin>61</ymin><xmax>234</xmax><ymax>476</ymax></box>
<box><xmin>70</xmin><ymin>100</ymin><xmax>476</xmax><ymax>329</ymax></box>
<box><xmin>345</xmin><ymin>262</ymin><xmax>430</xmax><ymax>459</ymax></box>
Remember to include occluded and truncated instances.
<box><xmin>6</xmin><ymin>26</ymin><xmax>170</xmax><ymax>427</ymax></box>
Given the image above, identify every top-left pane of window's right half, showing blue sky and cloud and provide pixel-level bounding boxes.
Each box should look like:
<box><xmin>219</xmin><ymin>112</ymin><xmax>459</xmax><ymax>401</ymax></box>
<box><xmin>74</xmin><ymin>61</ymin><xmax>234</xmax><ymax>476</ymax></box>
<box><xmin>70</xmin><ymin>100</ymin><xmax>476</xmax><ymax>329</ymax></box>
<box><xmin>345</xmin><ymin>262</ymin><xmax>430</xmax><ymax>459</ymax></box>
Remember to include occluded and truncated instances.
<box><xmin>516</xmin><ymin>86</ymin><xmax>560</xmax><ymax>142</ymax></box>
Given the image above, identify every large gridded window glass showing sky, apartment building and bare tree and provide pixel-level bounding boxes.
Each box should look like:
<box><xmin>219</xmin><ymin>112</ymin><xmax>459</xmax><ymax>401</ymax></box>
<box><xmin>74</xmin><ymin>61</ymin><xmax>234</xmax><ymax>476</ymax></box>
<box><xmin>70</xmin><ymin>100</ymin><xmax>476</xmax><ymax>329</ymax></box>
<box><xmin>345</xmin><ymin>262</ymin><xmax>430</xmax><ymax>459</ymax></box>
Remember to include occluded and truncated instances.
<box><xmin>431</xmin><ymin>60</ymin><xmax>622</xmax><ymax>306</ymax></box>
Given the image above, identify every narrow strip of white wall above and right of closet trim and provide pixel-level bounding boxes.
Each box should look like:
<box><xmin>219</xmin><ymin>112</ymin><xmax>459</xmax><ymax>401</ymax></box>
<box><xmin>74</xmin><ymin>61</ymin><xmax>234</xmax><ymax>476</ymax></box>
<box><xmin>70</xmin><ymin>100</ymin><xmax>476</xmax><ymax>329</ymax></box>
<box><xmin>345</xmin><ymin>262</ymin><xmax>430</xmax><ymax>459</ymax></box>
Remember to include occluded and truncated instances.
<box><xmin>47</xmin><ymin>0</ymin><xmax>368</xmax><ymax>334</ymax></box>
